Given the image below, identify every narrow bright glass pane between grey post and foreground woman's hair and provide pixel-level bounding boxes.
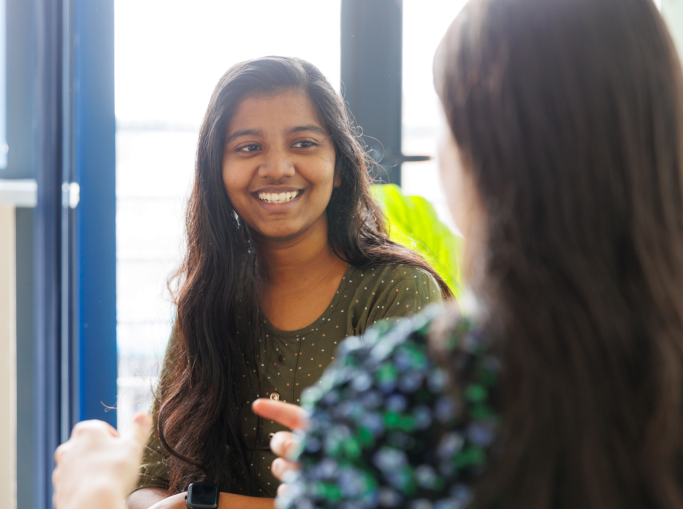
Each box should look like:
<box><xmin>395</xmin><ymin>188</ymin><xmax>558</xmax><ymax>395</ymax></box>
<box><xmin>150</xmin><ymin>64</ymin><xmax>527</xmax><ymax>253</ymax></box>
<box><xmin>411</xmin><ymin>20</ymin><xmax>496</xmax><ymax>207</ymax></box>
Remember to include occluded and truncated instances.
<box><xmin>401</xmin><ymin>0</ymin><xmax>466</xmax><ymax>228</ymax></box>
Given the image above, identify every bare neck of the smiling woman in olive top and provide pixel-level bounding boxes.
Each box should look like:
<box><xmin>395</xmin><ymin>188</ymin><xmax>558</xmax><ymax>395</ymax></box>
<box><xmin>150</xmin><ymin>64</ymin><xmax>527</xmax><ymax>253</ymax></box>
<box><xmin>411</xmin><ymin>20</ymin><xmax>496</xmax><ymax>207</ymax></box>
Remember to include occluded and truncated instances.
<box><xmin>258</xmin><ymin>216</ymin><xmax>347</xmax><ymax>288</ymax></box>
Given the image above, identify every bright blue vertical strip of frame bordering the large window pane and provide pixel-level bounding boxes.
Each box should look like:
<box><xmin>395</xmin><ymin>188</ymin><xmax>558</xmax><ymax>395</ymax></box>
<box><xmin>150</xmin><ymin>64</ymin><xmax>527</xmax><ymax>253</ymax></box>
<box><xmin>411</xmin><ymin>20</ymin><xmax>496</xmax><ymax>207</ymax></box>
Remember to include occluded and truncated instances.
<box><xmin>73</xmin><ymin>0</ymin><xmax>117</xmax><ymax>426</ymax></box>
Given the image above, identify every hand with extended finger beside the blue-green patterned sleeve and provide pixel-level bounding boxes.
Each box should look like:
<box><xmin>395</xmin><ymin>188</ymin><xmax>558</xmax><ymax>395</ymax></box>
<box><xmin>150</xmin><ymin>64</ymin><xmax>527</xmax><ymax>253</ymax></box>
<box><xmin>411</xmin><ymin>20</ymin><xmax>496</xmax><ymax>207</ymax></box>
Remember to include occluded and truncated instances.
<box><xmin>251</xmin><ymin>398</ymin><xmax>308</xmax><ymax>495</ymax></box>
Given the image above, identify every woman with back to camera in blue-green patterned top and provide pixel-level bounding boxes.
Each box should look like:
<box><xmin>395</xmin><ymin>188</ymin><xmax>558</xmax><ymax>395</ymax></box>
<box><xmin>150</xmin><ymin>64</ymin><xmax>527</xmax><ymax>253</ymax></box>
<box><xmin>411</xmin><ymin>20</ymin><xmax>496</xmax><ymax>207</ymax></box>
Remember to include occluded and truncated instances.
<box><xmin>254</xmin><ymin>0</ymin><xmax>683</xmax><ymax>509</ymax></box>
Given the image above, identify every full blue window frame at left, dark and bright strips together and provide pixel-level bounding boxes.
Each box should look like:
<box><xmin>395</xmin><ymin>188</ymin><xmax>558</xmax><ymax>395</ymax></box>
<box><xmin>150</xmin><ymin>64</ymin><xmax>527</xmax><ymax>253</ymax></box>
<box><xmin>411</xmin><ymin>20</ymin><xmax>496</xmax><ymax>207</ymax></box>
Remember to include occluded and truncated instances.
<box><xmin>33</xmin><ymin>0</ymin><xmax>116</xmax><ymax>509</ymax></box>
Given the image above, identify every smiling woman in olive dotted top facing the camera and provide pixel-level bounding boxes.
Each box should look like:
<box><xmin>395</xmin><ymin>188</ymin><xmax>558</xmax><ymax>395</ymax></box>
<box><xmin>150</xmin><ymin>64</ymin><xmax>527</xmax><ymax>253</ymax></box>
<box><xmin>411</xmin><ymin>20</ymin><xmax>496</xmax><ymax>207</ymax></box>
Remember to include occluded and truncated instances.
<box><xmin>128</xmin><ymin>57</ymin><xmax>451</xmax><ymax>509</ymax></box>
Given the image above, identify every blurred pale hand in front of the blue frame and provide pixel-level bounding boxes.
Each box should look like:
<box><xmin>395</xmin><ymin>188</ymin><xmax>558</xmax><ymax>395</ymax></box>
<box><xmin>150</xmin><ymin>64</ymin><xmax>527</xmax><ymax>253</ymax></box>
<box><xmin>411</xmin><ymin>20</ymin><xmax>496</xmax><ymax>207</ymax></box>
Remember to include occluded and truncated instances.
<box><xmin>52</xmin><ymin>413</ymin><xmax>151</xmax><ymax>509</ymax></box>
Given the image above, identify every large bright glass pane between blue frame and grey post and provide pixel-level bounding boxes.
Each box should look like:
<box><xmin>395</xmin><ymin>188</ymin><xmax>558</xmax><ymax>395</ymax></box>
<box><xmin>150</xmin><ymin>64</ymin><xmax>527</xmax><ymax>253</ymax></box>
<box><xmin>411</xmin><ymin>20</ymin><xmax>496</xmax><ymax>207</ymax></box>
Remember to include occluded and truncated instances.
<box><xmin>115</xmin><ymin>0</ymin><xmax>341</xmax><ymax>424</ymax></box>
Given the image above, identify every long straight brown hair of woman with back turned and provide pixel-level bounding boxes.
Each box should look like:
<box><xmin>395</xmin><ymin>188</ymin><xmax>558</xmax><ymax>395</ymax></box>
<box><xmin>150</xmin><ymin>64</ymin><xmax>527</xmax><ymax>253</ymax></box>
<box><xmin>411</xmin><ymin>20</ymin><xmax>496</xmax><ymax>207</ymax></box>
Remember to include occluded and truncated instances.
<box><xmin>435</xmin><ymin>0</ymin><xmax>683</xmax><ymax>509</ymax></box>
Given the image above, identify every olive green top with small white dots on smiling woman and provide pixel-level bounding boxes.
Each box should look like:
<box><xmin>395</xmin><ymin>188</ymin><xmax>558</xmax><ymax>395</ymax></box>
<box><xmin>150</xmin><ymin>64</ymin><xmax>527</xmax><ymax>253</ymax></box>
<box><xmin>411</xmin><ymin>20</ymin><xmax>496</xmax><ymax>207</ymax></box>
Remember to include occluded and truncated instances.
<box><xmin>137</xmin><ymin>265</ymin><xmax>442</xmax><ymax>497</ymax></box>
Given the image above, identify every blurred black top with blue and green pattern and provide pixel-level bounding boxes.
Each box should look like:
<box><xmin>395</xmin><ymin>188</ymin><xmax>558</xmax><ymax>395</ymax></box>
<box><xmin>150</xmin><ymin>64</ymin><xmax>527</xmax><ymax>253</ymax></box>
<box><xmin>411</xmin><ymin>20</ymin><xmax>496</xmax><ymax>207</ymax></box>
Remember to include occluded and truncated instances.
<box><xmin>277</xmin><ymin>308</ymin><xmax>499</xmax><ymax>509</ymax></box>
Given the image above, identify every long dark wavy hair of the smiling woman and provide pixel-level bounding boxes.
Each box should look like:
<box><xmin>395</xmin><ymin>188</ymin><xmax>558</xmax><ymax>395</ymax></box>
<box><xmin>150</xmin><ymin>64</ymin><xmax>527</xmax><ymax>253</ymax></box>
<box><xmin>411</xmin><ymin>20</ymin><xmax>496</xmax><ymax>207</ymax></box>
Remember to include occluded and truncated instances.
<box><xmin>158</xmin><ymin>57</ymin><xmax>451</xmax><ymax>493</ymax></box>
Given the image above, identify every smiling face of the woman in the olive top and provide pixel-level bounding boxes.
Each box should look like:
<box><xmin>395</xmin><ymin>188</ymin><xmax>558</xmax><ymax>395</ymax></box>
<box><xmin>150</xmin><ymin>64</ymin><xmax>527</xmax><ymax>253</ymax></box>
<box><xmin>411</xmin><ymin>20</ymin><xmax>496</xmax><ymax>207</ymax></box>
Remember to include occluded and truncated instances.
<box><xmin>223</xmin><ymin>90</ymin><xmax>340</xmax><ymax>240</ymax></box>
